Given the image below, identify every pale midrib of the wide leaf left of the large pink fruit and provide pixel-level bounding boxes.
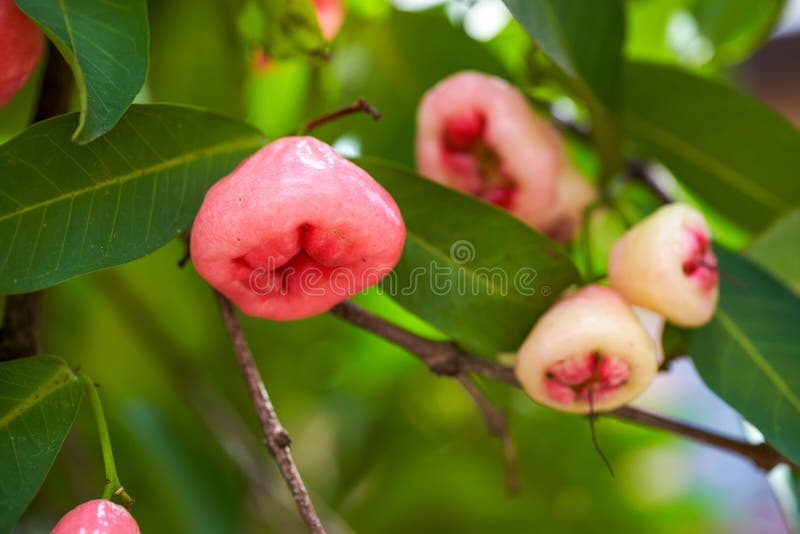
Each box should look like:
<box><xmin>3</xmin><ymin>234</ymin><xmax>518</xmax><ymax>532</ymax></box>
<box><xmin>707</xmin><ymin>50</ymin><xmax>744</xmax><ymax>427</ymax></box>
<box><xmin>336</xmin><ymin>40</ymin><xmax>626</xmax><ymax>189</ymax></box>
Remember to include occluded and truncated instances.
<box><xmin>0</xmin><ymin>136</ymin><xmax>263</xmax><ymax>222</ymax></box>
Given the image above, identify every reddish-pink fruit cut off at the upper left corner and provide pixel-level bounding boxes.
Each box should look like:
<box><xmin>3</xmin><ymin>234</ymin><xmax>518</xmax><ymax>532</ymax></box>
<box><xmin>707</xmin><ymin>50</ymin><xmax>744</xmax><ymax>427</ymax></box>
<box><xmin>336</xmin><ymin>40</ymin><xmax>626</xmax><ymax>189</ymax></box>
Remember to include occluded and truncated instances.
<box><xmin>0</xmin><ymin>0</ymin><xmax>44</xmax><ymax>106</ymax></box>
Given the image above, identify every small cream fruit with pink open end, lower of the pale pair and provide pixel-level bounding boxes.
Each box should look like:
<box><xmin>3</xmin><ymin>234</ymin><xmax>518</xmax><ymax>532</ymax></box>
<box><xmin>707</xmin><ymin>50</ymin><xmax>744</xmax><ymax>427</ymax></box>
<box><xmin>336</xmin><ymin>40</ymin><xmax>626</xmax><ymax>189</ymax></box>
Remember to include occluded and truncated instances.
<box><xmin>515</xmin><ymin>285</ymin><xmax>657</xmax><ymax>413</ymax></box>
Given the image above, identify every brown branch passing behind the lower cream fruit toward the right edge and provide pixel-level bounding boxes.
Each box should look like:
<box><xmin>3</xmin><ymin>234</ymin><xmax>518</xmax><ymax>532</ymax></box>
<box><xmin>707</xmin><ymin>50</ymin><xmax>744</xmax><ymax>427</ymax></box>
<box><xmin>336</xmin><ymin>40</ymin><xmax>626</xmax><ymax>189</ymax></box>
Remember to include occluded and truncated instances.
<box><xmin>331</xmin><ymin>302</ymin><xmax>800</xmax><ymax>471</ymax></box>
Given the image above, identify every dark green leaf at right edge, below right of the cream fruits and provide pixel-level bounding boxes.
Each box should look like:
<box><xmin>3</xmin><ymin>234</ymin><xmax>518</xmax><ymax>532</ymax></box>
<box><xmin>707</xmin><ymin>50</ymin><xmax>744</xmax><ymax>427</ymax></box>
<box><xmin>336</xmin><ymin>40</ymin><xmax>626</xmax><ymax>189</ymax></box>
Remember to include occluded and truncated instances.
<box><xmin>689</xmin><ymin>249</ymin><xmax>800</xmax><ymax>461</ymax></box>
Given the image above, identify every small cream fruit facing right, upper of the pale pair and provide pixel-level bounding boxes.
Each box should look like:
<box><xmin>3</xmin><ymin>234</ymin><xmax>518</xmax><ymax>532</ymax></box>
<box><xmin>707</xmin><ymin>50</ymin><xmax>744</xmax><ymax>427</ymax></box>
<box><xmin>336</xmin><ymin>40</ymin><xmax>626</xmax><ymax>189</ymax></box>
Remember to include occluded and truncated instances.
<box><xmin>608</xmin><ymin>204</ymin><xmax>719</xmax><ymax>326</ymax></box>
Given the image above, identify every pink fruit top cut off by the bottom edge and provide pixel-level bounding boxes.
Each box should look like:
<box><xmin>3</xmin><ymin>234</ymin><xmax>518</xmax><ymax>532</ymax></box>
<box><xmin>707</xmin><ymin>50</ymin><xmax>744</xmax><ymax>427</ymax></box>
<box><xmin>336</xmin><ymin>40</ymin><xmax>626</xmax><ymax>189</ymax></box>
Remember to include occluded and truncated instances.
<box><xmin>50</xmin><ymin>499</ymin><xmax>139</xmax><ymax>534</ymax></box>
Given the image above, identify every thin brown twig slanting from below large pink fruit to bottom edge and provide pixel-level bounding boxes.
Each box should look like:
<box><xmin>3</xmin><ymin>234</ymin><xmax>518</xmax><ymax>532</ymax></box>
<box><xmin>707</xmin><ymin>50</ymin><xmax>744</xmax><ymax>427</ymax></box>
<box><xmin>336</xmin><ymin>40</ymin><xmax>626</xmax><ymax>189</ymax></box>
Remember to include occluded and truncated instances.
<box><xmin>214</xmin><ymin>291</ymin><xmax>325</xmax><ymax>534</ymax></box>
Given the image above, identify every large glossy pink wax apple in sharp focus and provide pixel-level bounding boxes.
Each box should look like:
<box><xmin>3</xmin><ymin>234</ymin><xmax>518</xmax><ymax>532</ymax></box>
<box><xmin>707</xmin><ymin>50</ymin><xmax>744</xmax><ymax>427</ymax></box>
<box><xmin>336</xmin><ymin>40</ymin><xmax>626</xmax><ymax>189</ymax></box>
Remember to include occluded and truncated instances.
<box><xmin>190</xmin><ymin>137</ymin><xmax>406</xmax><ymax>320</ymax></box>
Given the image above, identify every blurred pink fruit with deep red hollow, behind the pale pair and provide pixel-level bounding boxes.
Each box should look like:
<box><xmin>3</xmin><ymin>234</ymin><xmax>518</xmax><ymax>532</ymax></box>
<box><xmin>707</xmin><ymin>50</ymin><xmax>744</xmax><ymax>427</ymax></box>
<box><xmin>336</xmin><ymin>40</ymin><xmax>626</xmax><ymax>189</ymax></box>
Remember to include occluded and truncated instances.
<box><xmin>416</xmin><ymin>72</ymin><xmax>564</xmax><ymax>230</ymax></box>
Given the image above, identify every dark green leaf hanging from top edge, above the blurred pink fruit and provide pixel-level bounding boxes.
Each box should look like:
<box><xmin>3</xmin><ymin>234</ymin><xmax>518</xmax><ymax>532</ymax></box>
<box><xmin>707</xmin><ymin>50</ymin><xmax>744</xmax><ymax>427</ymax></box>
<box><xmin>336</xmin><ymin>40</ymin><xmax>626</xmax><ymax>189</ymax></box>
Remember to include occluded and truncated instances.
<box><xmin>505</xmin><ymin>0</ymin><xmax>625</xmax><ymax>108</ymax></box>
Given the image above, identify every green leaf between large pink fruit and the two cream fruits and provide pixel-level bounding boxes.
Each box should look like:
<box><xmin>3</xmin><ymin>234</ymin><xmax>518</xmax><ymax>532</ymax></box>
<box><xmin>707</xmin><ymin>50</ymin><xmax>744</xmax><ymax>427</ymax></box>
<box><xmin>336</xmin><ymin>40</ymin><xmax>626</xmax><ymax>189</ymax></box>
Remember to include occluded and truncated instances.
<box><xmin>356</xmin><ymin>158</ymin><xmax>579</xmax><ymax>353</ymax></box>
